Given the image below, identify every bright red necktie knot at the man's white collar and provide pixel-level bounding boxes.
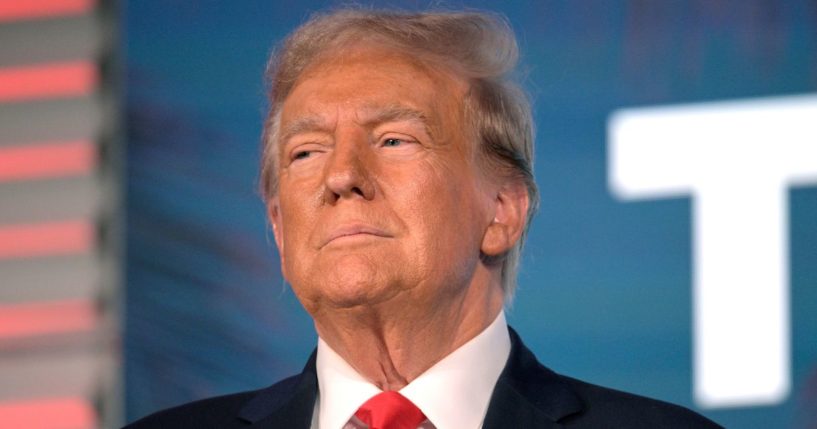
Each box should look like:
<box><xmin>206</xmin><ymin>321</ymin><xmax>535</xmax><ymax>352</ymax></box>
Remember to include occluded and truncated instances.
<box><xmin>355</xmin><ymin>391</ymin><xmax>426</xmax><ymax>429</ymax></box>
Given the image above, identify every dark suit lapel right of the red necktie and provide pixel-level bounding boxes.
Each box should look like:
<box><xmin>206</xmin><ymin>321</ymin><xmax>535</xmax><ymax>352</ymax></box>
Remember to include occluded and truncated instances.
<box><xmin>483</xmin><ymin>328</ymin><xmax>583</xmax><ymax>429</ymax></box>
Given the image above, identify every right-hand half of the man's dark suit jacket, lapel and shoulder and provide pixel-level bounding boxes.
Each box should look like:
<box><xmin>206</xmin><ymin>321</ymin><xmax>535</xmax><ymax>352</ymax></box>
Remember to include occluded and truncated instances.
<box><xmin>483</xmin><ymin>329</ymin><xmax>721</xmax><ymax>429</ymax></box>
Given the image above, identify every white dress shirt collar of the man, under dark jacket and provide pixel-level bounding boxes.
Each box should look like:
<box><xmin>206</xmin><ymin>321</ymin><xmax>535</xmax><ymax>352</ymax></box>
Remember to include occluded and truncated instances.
<box><xmin>312</xmin><ymin>311</ymin><xmax>511</xmax><ymax>429</ymax></box>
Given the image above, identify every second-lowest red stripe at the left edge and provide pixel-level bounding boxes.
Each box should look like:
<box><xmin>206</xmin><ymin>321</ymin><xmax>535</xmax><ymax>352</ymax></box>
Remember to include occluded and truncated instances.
<box><xmin>0</xmin><ymin>300</ymin><xmax>97</xmax><ymax>340</ymax></box>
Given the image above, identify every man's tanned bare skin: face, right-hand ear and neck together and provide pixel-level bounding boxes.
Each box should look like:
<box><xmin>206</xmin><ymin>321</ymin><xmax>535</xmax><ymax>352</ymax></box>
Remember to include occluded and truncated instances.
<box><xmin>268</xmin><ymin>47</ymin><xmax>528</xmax><ymax>390</ymax></box>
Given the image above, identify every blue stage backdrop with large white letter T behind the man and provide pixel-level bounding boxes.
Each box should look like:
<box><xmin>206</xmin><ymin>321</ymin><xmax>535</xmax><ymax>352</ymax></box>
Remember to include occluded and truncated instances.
<box><xmin>123</xmin><ymin>0</ymin><xmax>817</xmax><ymax>428</ymax></box>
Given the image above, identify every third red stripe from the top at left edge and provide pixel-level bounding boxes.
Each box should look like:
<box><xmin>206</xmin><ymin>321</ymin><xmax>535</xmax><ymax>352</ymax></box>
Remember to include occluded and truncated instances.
<box><xmin>0</xmin><ymin>140</ymin><xmax>96</xmax><ymax>182</ymax></box>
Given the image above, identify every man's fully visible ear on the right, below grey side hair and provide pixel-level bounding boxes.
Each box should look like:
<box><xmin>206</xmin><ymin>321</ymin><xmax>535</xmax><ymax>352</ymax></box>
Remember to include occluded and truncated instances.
<box><xmin>480</xmin><ymin>180</ymin><xmax>530</xmax><ymax>256</ymax></box>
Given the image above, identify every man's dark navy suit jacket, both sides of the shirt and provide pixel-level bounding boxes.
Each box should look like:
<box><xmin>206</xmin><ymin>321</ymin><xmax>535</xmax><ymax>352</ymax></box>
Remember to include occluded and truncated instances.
<box><xmin>127</xmin><ymin>329</ymin><xmax>720</xmax><ymax>429</ymax></box>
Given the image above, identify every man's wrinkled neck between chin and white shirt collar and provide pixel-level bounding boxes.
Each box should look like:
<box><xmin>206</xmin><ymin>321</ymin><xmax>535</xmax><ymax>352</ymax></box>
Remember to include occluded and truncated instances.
<box><xmin>313</xmin><ymin>272</ymin><xmax>503</xmax><ymax>391</ymax></box>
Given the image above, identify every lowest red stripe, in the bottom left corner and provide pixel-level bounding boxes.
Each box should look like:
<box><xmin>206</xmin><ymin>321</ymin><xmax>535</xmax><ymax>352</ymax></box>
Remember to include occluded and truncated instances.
<box><xmin>0</xmin><ymin>398</ymin><xmax>97</xmax><ymax>429</ymax></box>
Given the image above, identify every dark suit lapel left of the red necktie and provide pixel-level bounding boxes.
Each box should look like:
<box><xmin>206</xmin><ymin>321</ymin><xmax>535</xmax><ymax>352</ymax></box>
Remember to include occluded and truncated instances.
<box><xmin>239</xmin><ymin>352</ymin><xmax>318</xmax><ymax>429</ymax></box>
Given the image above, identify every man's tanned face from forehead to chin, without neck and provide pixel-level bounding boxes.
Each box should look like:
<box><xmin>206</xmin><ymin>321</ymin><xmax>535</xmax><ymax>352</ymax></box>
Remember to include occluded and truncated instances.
<box><xmin>268</xmin><ymin>49</ymin><xmax>495</xmax><ymax>315</ymax></box>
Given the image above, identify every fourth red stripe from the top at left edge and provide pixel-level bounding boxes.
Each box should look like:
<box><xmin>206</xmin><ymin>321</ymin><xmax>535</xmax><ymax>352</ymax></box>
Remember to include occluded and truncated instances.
<box><xmin>0</xmin><ymin>219</ymin><xmax>94</xmax><ymax>259</ymax></box>
